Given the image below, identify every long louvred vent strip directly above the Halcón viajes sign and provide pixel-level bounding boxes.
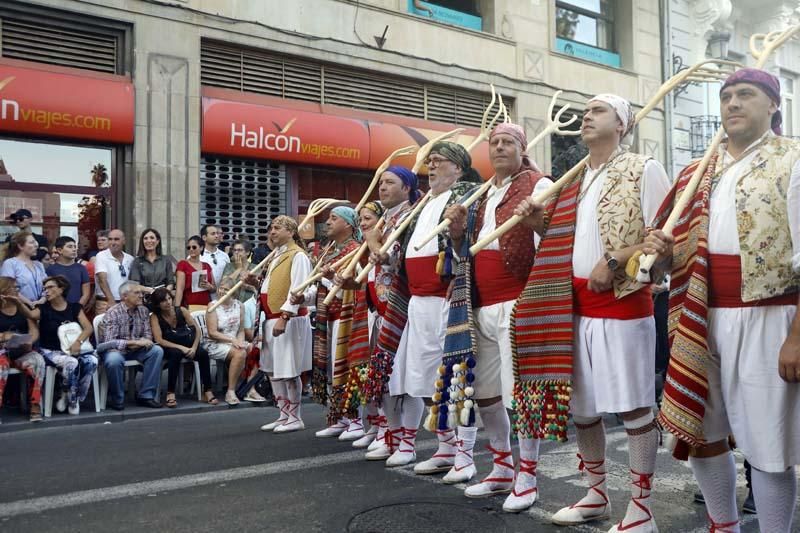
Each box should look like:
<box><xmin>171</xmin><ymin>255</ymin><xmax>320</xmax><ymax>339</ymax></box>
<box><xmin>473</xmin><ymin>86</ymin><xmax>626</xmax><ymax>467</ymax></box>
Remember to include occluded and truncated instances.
<box><xmin>200</xmin><ymin>41</ymin><xmax>513</xmax><ymax>127</ymax></box>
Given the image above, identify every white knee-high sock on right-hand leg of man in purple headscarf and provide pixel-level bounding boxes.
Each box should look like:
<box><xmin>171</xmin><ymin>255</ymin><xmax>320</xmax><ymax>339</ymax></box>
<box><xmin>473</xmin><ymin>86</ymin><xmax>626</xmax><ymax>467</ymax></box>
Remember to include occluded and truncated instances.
<box><xmin>752</xmin><ymin>467</ymin><xmax>797</xmax><ymax>533</ymax></box>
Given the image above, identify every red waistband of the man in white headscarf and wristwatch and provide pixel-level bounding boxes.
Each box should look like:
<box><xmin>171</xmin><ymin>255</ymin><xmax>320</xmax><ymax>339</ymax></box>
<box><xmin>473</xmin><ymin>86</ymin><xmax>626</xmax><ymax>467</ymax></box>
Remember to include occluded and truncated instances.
<box><xmin>572</xmin><ymin>277</ymin><xmax>653</xmax><ymax>320</ymax></box>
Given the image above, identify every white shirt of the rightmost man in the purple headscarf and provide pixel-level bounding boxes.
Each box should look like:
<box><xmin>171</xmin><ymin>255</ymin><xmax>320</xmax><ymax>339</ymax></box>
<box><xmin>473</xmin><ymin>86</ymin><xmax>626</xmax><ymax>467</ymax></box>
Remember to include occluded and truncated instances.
<box><xmin>708</xmin><ymin>131</ymin><xmax>800</xmax><ymax>272</ymax></box>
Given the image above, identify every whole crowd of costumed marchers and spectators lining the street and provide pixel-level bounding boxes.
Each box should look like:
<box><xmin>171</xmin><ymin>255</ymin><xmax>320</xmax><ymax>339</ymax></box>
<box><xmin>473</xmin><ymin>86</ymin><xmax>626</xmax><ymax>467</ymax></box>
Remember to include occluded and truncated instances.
<box><xmin>0</xmin><ymin>68</ymin><xmax>800</xmax><ymax>533</ymax></box>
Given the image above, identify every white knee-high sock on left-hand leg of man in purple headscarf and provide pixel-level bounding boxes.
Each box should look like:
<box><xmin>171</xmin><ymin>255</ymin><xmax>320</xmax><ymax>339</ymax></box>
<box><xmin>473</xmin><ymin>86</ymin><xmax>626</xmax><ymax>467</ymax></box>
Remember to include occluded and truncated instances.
<box><xmin>689</xmin><ymin>452</ymin><xmax>744</xmax><ymax>532</ymax></box>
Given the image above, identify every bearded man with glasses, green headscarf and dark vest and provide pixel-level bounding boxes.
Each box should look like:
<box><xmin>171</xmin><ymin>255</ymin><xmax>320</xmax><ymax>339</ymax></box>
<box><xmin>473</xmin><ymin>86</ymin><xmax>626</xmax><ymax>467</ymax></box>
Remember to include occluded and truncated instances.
<box><xmin>367</xmin><ymin>141</ymin><xmax>480</xmax><ymax>467</ymax></box>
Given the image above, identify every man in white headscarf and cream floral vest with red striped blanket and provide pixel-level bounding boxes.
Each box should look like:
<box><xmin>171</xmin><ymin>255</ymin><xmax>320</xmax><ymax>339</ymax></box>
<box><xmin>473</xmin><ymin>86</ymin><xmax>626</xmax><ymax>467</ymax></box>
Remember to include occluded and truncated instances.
<box><xmin>513</xmin><ymin>94</ymin><xmax>670</xmax><ymax>532</ymax></box>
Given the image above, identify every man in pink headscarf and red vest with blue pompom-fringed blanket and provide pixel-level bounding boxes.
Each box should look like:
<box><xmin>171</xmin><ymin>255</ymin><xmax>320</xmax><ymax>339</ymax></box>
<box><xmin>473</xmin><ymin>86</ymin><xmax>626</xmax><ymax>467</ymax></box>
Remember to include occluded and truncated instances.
<box><xmin>432</xmin><ymin>123</ymin><xmax>553</xmax><ymax>511</ymax></box>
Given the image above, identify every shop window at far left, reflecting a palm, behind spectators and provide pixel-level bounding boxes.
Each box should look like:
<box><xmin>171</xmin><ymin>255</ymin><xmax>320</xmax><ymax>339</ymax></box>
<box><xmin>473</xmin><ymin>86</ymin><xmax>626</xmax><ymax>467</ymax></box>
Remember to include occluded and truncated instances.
<box><xmin>0</xmin><ymin>138</ymin><xmax>115</xmax><ymax>254</ymax></box>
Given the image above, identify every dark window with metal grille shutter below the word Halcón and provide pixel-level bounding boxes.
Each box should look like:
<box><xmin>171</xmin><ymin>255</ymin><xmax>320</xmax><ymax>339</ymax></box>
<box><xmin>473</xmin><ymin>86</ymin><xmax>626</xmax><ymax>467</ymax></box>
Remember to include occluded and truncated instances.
<box><xmin>200</xmin><ymin>156</ymin><xmax>288</xmax><ymax>242</ymax></box>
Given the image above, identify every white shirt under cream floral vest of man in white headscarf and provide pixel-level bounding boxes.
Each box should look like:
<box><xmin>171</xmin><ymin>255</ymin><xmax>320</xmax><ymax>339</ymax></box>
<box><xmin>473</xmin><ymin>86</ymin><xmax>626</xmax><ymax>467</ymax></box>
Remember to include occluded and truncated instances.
<box><xmin>572</xmin><ymin>159</ymin><xmax>672</xmax><ymax>278</ymax></box>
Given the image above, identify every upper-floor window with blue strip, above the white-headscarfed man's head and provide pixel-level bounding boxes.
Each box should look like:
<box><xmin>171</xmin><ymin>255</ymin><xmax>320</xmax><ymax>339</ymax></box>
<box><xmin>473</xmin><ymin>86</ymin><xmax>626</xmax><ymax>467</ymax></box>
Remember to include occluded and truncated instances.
<box><xmin>556</xmin><ymin>0</ymin><xmax>620</xmax><ymax>67</ymax></box>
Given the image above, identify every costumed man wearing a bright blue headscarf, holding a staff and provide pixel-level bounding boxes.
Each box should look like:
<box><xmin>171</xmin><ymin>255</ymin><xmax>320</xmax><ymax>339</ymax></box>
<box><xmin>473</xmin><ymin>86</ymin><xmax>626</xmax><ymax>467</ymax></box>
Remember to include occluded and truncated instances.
<box><xmin>345</xmin><ymin>165</ymin><xmax>420</xmax><ymax>454</ymax></box>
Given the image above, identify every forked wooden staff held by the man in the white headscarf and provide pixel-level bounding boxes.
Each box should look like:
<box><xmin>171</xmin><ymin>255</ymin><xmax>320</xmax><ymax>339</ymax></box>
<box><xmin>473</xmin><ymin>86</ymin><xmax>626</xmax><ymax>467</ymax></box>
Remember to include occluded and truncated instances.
<box><xmin>469</xmin><ymin>59</ymin><xmax>741</xmax><ymax>256</ymax></box>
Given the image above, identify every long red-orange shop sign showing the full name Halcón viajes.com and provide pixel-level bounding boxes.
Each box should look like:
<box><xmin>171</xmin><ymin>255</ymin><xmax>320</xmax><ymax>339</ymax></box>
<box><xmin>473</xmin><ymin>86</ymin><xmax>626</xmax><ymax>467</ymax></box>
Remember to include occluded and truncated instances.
<box><xmin>201</xmin><ymin>87</ymin><xmax>492</xmax><ymax>178</ymax></box>
